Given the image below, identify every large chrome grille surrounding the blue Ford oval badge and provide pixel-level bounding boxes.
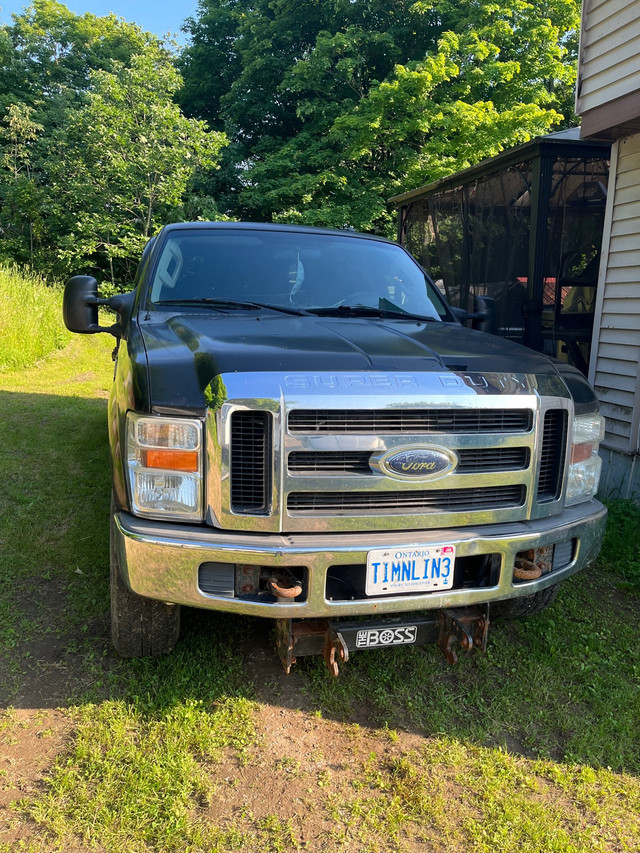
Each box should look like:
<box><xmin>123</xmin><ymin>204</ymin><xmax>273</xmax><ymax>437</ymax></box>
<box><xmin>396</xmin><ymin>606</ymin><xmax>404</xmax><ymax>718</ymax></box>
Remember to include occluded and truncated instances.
<box><xmin>206</xmin><ymin>372</ymin><xmax>571</xmax><ymax>534</ymax></box>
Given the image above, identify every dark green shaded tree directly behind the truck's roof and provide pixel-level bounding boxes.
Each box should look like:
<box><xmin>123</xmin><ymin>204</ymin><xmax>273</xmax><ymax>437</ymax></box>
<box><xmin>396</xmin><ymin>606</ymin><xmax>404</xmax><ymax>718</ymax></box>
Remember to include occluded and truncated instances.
<box><xmin>179</xmin><ymin>0</ymin><xmax>440</xmax><ymax>218</ymax></box>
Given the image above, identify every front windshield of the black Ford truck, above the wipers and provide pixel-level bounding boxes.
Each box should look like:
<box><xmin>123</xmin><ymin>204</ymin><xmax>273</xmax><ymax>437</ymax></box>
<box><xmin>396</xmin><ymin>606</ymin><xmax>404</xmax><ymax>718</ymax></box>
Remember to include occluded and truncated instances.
<box><xmin>150</xmin><ymin>229</ymin><xmax>448</xmax><ymax>320</ymax></box>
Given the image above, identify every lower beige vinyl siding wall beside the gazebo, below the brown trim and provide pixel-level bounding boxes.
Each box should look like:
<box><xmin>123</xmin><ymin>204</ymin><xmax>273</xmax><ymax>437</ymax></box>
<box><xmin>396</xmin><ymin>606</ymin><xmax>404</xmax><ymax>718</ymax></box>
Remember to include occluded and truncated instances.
<box><xmin>589</xmin><ymin>135</ymin><xmax>640</xmax><ymax>452</ymax></box>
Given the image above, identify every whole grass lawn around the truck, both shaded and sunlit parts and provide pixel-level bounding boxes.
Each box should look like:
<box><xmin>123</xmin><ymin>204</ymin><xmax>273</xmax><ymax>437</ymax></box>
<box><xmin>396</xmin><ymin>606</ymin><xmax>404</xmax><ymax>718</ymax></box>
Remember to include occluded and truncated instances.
<box><xmin>0</xmin><ymin>335</ymin><xmax>640</xmax><ymax>853</ymax></box>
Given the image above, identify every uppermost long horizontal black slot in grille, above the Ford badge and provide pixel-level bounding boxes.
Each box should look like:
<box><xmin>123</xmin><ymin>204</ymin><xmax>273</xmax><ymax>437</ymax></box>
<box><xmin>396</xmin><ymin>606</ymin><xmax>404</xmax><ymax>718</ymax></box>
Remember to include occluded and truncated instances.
<box><xmin>288</xmin><ymin>409</ymin><xmax>533</xmax><ymax>435</ymax></box>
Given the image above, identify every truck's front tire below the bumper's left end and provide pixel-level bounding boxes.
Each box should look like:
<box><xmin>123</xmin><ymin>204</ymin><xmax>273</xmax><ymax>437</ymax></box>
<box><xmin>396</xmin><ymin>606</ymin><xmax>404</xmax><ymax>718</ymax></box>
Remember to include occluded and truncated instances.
<box><xmin>109</xmin><ymin>503</ymin><xmax>180</xmax><ymax>658</ymax></box>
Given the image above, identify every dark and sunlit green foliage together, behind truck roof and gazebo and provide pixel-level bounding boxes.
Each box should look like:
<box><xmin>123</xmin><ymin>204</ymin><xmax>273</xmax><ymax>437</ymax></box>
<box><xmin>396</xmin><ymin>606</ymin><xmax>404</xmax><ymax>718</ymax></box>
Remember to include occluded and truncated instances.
<box><xmin>180</xmin><ymin>0</ymin><xmax>579</xmax><ymax>230</ymax></box>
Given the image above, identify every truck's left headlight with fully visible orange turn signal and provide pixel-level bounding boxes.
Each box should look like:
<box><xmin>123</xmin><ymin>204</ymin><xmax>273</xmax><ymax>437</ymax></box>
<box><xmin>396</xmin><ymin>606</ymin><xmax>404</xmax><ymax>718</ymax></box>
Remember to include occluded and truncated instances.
<box><xmin>127</xmin><ymin>412</ymin><xmax>202</xmax><ymax>521</ymax></box>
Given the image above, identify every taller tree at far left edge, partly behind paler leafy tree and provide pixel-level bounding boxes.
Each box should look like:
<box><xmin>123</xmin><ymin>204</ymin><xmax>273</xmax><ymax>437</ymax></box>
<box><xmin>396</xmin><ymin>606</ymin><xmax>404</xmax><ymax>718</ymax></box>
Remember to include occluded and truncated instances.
<box><xmin>0</xmin><ymin>0</ymin><xmax>159</xmax><ymax>273</ymax></box>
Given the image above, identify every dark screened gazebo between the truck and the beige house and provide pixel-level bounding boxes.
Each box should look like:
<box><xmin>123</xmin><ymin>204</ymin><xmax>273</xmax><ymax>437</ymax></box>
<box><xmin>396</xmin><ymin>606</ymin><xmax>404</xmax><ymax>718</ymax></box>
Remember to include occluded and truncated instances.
<box><xmin>391</xmin><ymin>128</ymin><xmax>610</xmax><ymax>374</ymax></box>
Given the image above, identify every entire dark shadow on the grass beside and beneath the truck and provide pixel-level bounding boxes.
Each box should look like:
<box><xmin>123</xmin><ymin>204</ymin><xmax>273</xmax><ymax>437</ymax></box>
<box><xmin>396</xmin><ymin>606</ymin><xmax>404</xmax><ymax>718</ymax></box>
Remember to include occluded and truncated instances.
<box><xmin>0</xmin><ymin>393</ymin><xmax>640</xmax><ymax>773</ymax></box>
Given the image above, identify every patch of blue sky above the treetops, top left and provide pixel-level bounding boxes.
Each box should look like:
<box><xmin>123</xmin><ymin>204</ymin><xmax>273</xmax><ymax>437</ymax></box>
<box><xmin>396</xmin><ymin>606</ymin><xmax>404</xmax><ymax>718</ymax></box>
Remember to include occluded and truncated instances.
<box><xmin>0</xmin><ymin>0</ymin><xmax>198</xmax><ymax>44</ymax></box>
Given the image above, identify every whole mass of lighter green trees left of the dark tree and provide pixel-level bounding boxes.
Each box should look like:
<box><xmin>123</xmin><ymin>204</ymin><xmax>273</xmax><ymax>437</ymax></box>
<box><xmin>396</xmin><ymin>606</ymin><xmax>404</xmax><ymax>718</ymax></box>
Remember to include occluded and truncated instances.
<box><xmin>0</xmin><ymin>0</ymin><xmax>225</xmax><ymax>280</ymax></box>
